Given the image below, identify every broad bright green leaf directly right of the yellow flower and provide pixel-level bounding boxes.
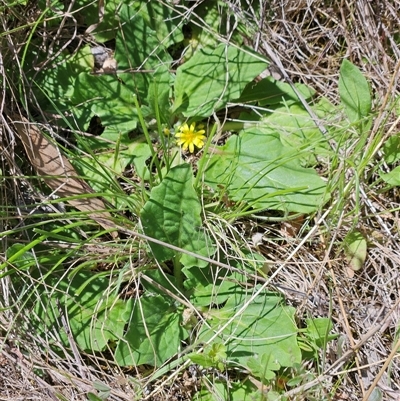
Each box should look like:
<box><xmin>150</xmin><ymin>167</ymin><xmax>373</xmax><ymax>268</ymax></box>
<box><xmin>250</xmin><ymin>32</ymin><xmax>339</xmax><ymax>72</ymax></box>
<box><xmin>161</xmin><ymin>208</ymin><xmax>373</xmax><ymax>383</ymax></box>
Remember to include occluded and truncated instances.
<box><xmin>205</xmin><ymin>128</ymin><xmax>326</xmax><ymax>213</ymax></box>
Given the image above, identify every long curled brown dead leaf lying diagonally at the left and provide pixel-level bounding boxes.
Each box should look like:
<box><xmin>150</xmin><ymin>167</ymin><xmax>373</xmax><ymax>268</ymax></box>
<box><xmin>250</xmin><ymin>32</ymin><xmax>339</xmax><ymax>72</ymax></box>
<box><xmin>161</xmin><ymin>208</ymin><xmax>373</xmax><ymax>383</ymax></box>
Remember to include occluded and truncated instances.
<box><xmin>14</xmin><ymin>117</ymin><xmax>118</xmax><ymax>238</ymax></box>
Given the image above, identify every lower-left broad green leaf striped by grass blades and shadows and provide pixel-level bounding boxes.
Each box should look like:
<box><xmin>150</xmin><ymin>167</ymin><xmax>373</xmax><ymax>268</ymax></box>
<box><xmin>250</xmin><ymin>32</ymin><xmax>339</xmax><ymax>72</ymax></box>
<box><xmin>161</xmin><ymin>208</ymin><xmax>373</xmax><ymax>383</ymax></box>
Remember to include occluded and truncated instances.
<box><xmin>33</xmin><ymin>271</ymin><xmax>132</xmax><ymax>352</ymax></box>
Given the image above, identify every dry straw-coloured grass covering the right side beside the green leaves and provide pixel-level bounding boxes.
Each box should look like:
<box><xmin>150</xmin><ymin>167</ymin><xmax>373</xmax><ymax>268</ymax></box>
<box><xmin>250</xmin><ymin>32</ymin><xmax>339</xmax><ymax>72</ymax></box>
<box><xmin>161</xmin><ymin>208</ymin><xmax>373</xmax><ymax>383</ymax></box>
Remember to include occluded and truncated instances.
<box><xmin>260</xmin><ymin>1</ymin><xmax>400</xmax><ymax>400</ymax></box>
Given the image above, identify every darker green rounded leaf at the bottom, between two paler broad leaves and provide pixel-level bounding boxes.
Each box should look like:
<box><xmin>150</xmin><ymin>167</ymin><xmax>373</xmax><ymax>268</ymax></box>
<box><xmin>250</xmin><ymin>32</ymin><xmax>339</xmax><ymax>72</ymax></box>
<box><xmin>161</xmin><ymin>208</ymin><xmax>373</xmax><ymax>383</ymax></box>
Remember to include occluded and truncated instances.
<box><xmin>115</xmin><ymin>295</ymin><xmax>188</xmax><ymax>366</ymax></box>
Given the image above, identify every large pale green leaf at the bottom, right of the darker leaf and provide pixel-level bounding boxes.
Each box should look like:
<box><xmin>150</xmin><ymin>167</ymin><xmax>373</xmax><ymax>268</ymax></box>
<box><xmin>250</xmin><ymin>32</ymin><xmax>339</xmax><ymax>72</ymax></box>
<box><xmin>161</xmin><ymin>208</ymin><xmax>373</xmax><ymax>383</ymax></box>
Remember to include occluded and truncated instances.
<box><xmin>199</xmin><ymin>287</ymin><xmax>301</xmax><ymax>367</ymax></box>
